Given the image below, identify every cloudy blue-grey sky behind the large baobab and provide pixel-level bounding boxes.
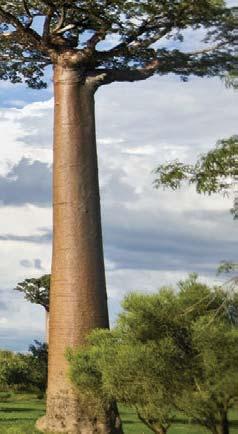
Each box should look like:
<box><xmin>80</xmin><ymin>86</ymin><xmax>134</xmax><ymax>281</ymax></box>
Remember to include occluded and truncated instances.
<box><xmin>0</xmin><ymin>6</ymin><xmax>238</xmax><ymax>351</ymax></box>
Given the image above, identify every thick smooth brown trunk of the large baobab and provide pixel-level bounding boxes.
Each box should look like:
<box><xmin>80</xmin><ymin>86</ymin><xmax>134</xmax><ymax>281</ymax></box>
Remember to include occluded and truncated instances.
<box><xmin>37</xmin><ymin>66</ymin><xmax>122</xmax><ymax>434</ymax></box>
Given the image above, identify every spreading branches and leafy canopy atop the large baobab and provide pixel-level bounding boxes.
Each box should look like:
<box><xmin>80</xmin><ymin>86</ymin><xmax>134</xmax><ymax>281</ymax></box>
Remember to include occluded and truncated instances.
<box><xmin>0</xmin><ymin>0</ymin><xmax>237</xmax><ymax>88</ymax></box>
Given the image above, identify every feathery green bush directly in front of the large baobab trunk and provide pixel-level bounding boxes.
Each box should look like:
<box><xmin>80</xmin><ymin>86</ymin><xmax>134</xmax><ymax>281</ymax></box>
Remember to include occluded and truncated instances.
<box><xmin>69</xmin><ymin>290</ymin><xmax>193</xmax><ymax>434</ymax></box>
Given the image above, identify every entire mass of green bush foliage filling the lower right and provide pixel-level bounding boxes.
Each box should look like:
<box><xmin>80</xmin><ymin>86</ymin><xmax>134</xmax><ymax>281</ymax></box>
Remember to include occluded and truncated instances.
<box><xmin>69</xmin><ymin>274</ymin><xmax>238</xmax><ymax>433</ymax></box>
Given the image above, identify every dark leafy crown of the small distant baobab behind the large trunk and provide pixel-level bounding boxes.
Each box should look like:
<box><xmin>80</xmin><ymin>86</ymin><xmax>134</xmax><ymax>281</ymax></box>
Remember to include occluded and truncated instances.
<box><xmin>14</xmin><ymin>274</ymin><xmax>50</xmax><ymax>312</ymax></box>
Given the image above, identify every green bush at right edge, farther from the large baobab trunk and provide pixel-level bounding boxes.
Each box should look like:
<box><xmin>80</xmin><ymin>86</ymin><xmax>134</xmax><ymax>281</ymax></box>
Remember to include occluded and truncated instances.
<box><xmin>177</xmin><ymin>274</ymin><xmax>238</xmax><ymax>434</ymax></box>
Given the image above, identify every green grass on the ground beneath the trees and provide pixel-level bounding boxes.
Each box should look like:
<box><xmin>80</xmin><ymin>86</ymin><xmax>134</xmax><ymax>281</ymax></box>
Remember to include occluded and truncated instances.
<box><xmin>0</xmin><ymin>393</ymin><xmax>238</xmax><ymax>434</ymax></box>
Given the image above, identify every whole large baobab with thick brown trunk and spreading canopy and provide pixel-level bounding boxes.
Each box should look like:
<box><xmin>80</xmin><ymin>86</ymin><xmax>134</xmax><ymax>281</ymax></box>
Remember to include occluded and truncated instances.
<box><xmin>0</xmin><ymin>0</ymin><xmax>235</xmax><ymax>433</ymax></box>
